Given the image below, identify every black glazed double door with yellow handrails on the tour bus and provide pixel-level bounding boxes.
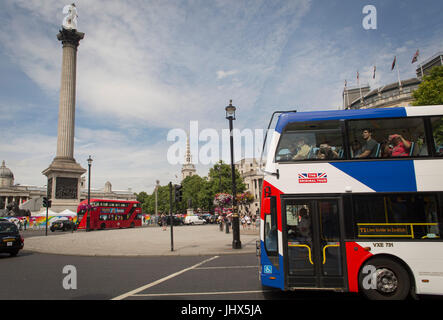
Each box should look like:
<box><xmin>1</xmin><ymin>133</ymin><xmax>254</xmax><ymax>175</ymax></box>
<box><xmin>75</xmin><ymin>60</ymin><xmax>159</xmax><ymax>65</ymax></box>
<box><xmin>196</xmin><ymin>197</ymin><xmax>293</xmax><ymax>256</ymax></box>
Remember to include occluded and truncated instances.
<box><xmin>282</xmin><ymin>198</ymin><xmax>345</xmax><ymax>289</ymax></box>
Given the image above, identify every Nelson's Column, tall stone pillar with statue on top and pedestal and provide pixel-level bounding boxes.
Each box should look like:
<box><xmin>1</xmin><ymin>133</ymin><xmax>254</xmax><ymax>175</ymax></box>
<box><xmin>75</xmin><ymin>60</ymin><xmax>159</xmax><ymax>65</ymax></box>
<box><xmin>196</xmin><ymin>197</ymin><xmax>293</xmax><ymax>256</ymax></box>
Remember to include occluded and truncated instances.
<box><xmin>42</xmin><ymin>4</ymin><xmax>86</xmax><ymax>212</ymax></box>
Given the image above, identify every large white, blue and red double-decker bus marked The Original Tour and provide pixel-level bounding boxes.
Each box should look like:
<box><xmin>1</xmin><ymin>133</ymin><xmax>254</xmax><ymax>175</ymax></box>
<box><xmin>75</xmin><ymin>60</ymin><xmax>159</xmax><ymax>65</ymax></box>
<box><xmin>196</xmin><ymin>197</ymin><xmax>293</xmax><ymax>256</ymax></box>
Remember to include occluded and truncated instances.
<box><xmin>258</xmin><ymin>106</ymin><xmax>443</xmax><ymax>299</ymax></box>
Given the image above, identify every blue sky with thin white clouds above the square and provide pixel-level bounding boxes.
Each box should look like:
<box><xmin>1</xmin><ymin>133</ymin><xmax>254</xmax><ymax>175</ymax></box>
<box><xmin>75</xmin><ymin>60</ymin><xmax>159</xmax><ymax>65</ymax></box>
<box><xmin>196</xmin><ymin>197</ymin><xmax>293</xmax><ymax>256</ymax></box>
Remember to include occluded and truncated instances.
<box><xmin>0</xmin><ymin>0</ymin><xmax>443</xmax><ymax>192</ymax></box>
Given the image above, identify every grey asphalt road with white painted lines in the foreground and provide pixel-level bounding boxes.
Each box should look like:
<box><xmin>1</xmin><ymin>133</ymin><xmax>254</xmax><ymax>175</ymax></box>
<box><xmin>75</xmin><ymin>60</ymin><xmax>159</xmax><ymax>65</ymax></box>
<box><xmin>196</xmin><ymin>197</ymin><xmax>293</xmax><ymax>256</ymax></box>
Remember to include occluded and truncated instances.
<box><xmin>0</xmin><ymin>250</ymin><xmax>360</xmax><ymax>300</ymax></box>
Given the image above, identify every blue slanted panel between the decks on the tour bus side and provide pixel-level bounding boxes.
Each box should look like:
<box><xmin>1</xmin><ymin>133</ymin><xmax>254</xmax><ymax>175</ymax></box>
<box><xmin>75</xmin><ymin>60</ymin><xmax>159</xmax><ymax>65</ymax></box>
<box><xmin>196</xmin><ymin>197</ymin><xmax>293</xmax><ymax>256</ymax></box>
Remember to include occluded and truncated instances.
<box><xmin>330</xmin><ymin>160</ymin><xmax>417</xmax><ymax>192</ymax></box>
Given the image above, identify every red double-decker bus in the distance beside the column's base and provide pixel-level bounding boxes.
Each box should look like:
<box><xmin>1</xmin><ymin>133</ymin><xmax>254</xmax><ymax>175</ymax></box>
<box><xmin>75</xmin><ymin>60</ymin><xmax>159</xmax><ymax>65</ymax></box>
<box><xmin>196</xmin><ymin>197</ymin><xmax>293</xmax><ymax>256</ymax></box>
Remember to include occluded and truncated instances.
<box><xmin>77</xmin><ymin>199</ymin><xmax>142</xmax><ymax>230</ymax></box>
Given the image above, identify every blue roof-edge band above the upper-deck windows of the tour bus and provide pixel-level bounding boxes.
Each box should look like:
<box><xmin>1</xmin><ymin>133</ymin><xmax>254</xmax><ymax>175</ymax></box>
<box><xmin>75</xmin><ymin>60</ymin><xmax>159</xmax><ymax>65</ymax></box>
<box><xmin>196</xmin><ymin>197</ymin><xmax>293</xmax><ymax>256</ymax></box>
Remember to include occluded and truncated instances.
<box><xmin>275</xmin><ymin>107</ymin><xmax>407</xmax><ymax>133</ymax></box>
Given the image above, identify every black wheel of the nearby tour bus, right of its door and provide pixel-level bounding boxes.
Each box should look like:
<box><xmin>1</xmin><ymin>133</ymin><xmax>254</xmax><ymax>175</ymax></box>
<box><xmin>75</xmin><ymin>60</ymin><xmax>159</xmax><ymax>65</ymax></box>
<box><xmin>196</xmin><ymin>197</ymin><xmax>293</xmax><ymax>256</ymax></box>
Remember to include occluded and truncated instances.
<box><xmin>358</xmin><ymin>257</ymin><xmax>411</xmax><ymax>300</ymax></box>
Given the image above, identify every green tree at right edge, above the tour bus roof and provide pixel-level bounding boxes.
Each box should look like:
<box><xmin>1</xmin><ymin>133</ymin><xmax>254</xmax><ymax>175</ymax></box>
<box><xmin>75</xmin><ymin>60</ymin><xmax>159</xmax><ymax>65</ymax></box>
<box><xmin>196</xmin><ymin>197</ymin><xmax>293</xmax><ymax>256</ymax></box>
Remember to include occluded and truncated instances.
<box><xmin>412</xmin><ymin>66</ymin><xmax>443</xmax><ymax>106</ymax></box>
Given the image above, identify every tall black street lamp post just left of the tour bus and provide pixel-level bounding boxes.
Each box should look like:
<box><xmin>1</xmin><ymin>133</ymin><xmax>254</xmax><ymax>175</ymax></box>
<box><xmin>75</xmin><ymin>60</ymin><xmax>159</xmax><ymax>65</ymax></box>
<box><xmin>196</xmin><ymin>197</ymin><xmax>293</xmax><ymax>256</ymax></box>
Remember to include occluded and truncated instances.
<box><xmin>225</xmin><ymin>100</ymin><xmax>241</xmax><ymax>249</ymax></box>
